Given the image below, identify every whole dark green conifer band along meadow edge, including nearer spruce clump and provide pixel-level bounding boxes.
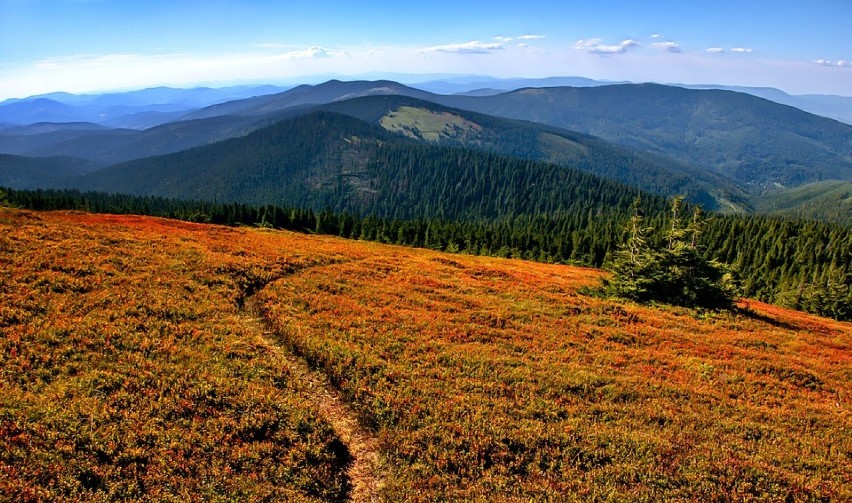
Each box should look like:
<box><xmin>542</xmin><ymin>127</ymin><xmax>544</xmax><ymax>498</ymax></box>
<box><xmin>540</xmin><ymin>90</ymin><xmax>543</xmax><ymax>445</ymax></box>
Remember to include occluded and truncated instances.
<box><xmin>0</xmin><ymin>189</ymin><xmax>852</xmax><ymax>320</ymax></box>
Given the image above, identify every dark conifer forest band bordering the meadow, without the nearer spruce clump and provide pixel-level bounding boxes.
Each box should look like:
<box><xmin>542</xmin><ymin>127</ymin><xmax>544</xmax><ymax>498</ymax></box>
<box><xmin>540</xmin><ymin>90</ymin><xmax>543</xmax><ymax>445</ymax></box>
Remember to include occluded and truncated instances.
<box><xmin>0</xmin><ymin>189</ymin><xmax>852</xmax><ymax>320</ymax></box>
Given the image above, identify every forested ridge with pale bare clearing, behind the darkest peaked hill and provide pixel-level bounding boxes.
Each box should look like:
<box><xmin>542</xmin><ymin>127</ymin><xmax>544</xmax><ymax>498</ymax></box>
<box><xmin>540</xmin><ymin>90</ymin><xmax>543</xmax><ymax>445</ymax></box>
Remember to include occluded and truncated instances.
<box><xmin>320</xmin><ymin>96</ymin><xmax>748</xmax><ymax>211</ymax></box>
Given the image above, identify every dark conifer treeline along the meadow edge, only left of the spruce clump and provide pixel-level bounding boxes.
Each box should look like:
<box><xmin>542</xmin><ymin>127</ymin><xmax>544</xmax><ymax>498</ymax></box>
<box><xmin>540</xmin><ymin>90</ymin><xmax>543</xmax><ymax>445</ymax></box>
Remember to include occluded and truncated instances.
<box><xmin>0</xmin><ymin>188</ymin><xmax>632</xmax><ymax>267</ymax></box>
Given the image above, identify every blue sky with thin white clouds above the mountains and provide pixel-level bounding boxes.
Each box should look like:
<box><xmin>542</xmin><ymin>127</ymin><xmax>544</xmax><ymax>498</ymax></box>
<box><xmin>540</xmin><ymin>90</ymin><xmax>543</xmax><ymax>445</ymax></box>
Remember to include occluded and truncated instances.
<box><xmin>0</xmin><ymin>0</ymin><xmax>852</xmax><ymax>99</ymax></box>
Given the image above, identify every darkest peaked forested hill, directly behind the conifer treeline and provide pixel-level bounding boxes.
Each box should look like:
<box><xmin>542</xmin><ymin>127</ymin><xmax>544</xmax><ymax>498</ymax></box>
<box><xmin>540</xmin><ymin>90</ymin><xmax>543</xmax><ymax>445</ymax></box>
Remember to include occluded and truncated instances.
<box><xmin>64</xmin><ymin>112</ymin><xmax>664</xmax><ymax>223</ymax></box>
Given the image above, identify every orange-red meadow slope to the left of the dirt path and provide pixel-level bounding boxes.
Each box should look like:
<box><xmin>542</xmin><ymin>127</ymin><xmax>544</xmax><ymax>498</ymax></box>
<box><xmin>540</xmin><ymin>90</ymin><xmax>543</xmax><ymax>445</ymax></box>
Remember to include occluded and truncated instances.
<box><xmin>0</xmin><ymin>208</ymin><xmax>348</xmax><ymax>501</ymax></box>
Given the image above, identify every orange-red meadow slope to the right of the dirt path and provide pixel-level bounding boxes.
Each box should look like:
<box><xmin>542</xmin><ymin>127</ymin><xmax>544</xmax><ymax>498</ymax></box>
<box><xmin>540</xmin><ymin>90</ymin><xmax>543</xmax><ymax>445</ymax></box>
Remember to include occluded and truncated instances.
<box><xmin>259</xmin><ymin>248</ymin><xmax>852</xmax><ymax>501</ymax></box>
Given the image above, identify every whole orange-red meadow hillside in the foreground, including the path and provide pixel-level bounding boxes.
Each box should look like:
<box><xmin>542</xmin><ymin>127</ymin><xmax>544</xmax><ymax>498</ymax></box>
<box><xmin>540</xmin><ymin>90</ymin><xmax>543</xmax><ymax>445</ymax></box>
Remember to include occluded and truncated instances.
<box><xmin>0</xmin><ymin>208</ymin><xmax>852</xmax><ymax>501</ymax></box>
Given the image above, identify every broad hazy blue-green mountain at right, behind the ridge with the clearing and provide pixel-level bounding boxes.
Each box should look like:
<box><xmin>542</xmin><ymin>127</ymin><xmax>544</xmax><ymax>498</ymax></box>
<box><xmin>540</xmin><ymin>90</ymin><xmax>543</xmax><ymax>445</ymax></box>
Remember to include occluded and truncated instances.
<box><xmin>436</xmin><ymin>84</ymin><xmax>852</xmax><ymax>192</ymax></box>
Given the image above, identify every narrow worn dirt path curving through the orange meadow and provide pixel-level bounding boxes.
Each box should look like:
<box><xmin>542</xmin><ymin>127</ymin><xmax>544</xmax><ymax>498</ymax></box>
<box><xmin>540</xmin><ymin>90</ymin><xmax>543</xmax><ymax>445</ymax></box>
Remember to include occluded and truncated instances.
<box><xmin>241</xmin><ymin>295</ymin><xmax>385</xmax><ymax>503</ymax></box>
